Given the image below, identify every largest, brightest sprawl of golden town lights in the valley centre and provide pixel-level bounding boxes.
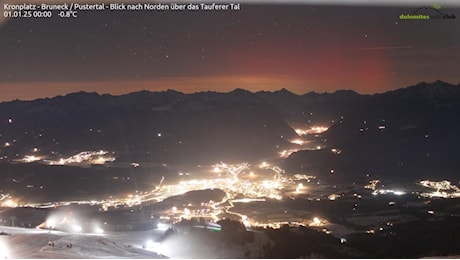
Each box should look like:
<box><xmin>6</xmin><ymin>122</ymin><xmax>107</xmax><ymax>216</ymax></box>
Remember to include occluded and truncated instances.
<box><xmin>23</xmin><ymin>161</ymin><xmax>315</xmax><ymax>231</ymax></box>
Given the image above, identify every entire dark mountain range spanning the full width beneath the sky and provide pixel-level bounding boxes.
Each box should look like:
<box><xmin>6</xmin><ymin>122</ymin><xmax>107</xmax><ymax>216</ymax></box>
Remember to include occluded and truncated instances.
<box><xmin>0</xmin><ymin>81</ymin><xmax>460</xmax><ymax>180</ymax></box>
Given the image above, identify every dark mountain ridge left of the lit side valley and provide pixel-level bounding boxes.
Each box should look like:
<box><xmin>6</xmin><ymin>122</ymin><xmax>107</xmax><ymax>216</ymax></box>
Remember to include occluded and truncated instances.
<box><xmin>0</xmin><ymin>87</ymin><xmax>295</xmax><ymax>163</ymax></box>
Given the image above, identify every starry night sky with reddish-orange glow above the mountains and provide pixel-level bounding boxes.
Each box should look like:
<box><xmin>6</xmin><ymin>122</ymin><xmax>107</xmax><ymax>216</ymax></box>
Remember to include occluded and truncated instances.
<box><xmin>0</xmin><ymin>1</ymin><xmax>460</xmax><ymax>101</ymax></box>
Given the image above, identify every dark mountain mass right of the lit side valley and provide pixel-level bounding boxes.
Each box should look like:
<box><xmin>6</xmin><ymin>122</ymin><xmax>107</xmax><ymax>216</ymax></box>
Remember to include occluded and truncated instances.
<box><xmin>285</xmin><ymin>81</ymin><xmax>460</xmax><ymax>182</ymax></box>
